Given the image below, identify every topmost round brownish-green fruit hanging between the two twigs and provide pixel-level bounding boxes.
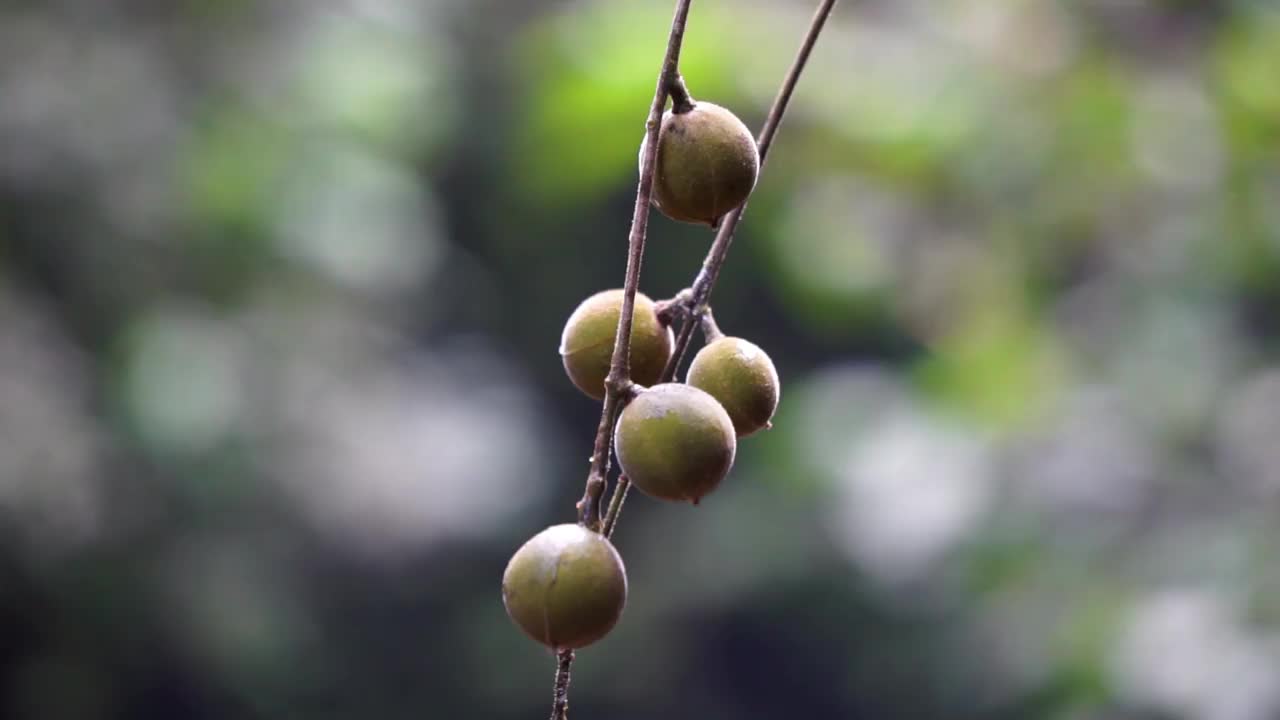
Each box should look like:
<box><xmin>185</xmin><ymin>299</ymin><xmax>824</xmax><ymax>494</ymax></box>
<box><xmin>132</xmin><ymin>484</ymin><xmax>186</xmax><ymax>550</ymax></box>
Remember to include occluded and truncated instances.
<box><xmin>653</xmin><ymin>101</ymin><xmax>760</xmax><ymax>228</ymax></box>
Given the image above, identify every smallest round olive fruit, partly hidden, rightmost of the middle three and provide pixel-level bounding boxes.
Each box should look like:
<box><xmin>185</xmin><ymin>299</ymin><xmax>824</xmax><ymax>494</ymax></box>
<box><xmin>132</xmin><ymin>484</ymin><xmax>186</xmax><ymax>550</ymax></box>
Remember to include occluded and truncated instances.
<box><xmin>685</xmin><ymin>337</ymin><xmax>781</xmax><ymax>437</ymax></box>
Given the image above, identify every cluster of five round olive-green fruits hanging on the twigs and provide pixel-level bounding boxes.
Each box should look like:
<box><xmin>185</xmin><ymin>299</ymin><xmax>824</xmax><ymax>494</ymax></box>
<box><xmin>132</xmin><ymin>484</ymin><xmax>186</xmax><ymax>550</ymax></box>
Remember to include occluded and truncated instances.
<box><xmin>502</xmin><ymin>96</ymin><xmax>778</xmax><ymax>651</ymax></box>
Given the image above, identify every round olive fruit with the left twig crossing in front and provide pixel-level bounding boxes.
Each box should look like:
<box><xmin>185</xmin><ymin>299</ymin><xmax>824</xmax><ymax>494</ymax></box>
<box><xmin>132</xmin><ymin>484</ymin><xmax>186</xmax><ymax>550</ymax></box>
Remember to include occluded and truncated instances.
<box><xmin>559</xmin><ymin>290</ymin><xmax>675</xmax><ymax>400</ymax></box>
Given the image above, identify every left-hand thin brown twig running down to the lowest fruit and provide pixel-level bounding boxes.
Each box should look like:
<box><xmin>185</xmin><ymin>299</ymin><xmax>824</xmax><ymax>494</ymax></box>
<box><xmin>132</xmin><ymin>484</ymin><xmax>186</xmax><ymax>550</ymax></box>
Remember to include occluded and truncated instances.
<box><xmin>577</xmin><ymin>0</ymin><xmax>692</xmax><ymax>532</ymax></box>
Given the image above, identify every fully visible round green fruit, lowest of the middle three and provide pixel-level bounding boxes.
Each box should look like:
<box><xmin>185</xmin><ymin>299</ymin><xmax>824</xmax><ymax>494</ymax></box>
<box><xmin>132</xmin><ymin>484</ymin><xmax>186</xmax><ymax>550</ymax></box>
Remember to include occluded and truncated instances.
<box><xmin>613</xmin><ymin>383</ymin><xmax>737</xmax><ymax>505</ymax></box>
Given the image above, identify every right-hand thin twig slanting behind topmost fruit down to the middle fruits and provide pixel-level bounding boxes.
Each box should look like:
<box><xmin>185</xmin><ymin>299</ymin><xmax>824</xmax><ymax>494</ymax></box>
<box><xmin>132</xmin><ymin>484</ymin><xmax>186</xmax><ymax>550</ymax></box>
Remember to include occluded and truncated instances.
<box><xmin>660</xmin><ymin>0</ymin><xmax>836</xmax><ymax>383</ymax></box>
